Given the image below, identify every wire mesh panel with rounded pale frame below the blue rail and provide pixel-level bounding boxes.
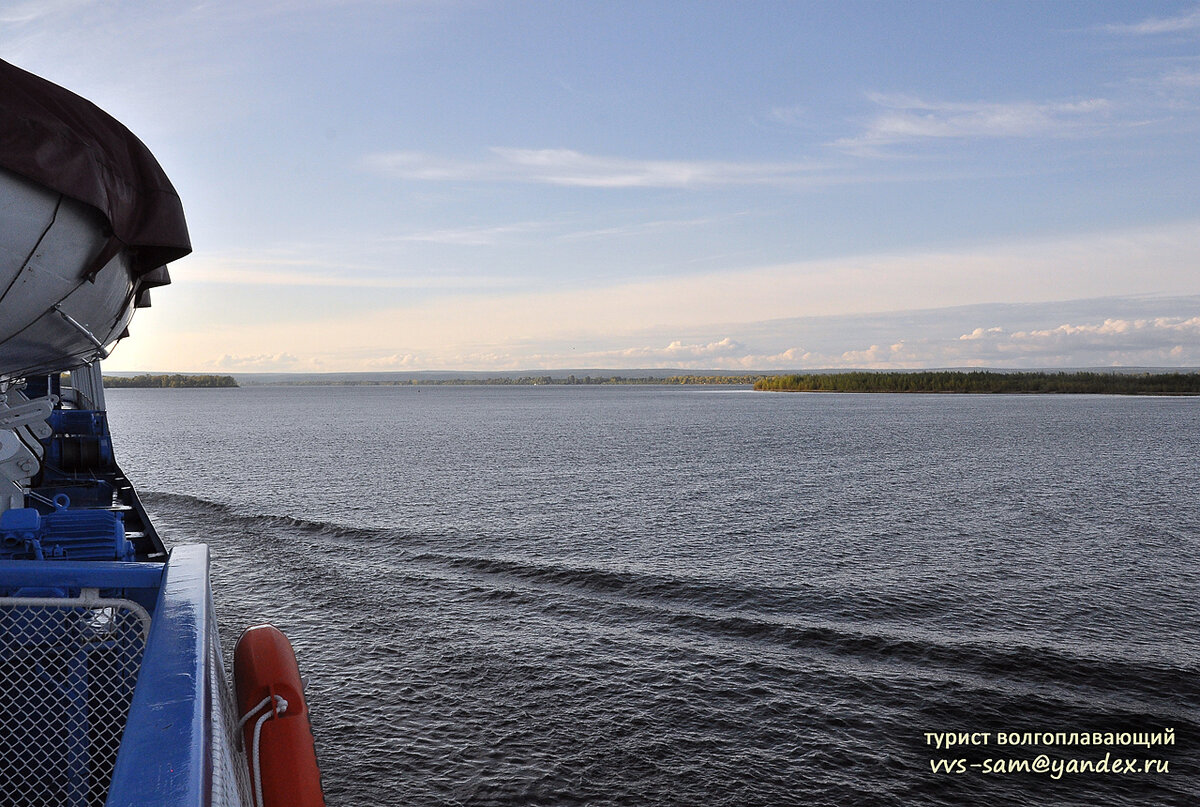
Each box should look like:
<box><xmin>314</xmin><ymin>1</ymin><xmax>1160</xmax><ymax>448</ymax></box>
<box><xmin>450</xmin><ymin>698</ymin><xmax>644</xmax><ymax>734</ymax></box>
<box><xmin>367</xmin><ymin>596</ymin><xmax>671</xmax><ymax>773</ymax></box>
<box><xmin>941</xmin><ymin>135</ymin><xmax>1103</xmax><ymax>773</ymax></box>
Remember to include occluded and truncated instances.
<box><xmin>0</xmin><ymin>590</ymin><xmax>150</xmax><ymax>807</ymax></box>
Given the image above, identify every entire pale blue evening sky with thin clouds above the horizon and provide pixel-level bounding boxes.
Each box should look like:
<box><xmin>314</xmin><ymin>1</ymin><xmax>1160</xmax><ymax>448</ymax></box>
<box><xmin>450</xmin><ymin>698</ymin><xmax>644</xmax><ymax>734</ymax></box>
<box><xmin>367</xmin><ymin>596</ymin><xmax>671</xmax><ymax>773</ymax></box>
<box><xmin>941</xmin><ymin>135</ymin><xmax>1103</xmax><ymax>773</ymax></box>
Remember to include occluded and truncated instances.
<box><xmin>0</xmin><ymin>0</ymin><xmax>1200</xmax><ymax>372</ymax></box>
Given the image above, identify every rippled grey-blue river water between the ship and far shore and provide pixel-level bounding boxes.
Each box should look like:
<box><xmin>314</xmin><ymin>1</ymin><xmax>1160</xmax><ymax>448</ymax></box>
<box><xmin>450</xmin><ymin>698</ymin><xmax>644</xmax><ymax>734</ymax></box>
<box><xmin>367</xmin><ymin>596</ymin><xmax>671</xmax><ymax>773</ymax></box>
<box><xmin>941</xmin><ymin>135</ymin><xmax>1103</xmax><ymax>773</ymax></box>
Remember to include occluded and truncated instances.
<box><xmin>108</xmin><ymin>387</ymin><xmax>1200</xmax><ymax>807</ymax></box>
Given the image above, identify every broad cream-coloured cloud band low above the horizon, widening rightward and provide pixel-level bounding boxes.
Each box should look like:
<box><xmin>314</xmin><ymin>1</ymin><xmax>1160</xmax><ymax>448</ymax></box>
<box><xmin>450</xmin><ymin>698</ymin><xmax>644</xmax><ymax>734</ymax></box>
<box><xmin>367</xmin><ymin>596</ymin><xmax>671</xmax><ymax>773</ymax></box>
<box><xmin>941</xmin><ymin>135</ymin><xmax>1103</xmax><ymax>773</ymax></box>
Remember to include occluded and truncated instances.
<box><xmin>105</xmin><ymin>221</ymin><xmax>1200</xmax><ymax>370</ymax></box>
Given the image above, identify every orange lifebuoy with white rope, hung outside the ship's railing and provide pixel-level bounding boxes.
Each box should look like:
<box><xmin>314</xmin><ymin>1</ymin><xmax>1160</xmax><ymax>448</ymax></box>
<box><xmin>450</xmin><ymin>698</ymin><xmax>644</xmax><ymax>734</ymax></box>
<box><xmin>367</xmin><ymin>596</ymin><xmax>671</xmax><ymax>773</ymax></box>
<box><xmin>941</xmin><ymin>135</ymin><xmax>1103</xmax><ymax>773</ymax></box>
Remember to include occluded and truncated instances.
<box><xmin>233</xmin><ymin>624</ymin><xmax>325</xmax><ymax>807</ymax></box>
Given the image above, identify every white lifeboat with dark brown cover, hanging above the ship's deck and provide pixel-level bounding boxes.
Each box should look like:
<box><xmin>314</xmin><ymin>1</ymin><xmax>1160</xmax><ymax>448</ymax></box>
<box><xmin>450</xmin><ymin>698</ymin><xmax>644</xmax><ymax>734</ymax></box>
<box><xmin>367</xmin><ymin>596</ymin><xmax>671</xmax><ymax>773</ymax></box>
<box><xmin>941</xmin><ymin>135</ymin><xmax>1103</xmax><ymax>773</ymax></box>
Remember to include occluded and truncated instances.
<box><xmin>0</xmin><ymin>61</ymin><xmax>191</xmax><ymax>383</ymax></box>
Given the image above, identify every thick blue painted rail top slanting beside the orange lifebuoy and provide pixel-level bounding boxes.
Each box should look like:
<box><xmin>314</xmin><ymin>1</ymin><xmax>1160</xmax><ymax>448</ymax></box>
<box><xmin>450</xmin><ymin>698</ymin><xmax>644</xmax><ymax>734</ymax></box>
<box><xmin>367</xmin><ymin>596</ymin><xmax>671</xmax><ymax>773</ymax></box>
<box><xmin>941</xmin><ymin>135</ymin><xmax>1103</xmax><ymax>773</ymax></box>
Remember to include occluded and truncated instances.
<box><xmin>107</xmin><ymin>545</ymin><xmax>217</xmax><ymax>807</ymax></box>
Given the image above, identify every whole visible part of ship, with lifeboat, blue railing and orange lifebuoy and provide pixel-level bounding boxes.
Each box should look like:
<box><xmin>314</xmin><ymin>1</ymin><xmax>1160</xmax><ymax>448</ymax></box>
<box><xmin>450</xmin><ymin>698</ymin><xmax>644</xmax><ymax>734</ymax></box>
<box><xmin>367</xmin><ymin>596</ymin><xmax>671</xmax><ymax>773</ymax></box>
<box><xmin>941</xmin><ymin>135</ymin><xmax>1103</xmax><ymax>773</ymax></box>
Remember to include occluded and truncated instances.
<box><xmin>0</xmin><ymin>56</ymin><xmax>324</xmax><ymax>807</ymax></box>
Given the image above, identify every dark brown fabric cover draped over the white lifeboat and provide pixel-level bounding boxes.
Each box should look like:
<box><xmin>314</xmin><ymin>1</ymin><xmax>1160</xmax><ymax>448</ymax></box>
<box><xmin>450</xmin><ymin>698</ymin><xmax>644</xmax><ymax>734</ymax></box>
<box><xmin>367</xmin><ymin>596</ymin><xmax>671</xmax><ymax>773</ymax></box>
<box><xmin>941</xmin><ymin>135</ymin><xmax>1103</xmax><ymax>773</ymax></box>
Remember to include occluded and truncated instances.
<box><xmin>0</xmin><ymin>60</ymin><xmax>192</xmax><ymax>283</ymax></box>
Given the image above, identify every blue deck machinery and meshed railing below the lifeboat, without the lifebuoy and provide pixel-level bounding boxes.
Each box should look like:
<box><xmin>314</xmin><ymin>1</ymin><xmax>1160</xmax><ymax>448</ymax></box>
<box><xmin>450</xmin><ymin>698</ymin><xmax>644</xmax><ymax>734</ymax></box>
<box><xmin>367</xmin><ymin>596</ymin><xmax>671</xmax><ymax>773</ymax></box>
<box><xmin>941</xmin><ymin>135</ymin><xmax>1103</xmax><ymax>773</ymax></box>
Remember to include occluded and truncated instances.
<box><xmin>0</xmin><ymin>365</ymin><xmax>248</xmax><ymax>807</ymax></box>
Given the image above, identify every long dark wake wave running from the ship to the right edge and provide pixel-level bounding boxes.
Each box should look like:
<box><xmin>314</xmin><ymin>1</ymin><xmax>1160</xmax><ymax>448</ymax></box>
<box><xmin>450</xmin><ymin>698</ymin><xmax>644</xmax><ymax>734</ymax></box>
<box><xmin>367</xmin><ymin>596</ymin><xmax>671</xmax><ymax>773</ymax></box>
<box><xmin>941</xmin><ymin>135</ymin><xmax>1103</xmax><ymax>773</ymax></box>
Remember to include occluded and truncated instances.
<box><xmin>136</xmin><ymin>491</ymin><xmax>1200</xmax><ymax>699</ymax></box>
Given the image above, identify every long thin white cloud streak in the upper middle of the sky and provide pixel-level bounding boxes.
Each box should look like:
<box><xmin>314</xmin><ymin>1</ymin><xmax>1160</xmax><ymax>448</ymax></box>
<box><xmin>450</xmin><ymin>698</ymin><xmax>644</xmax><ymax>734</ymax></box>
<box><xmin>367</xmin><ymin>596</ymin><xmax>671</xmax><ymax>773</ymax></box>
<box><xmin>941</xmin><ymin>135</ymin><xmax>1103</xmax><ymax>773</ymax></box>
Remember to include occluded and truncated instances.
<box><xmin>364</xmin><ymin>148</ymin><xmax>820</xmax><ymax>189</ymax></box>
